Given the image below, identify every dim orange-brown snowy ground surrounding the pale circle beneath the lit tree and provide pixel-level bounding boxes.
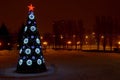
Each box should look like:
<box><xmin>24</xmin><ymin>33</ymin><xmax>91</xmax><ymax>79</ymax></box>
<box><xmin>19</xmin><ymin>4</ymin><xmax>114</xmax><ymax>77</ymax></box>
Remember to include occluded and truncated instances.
<box><xmin>0</xmin><ymin>49</ymin><xmax>120</xmax><ymax>80</ymax></box>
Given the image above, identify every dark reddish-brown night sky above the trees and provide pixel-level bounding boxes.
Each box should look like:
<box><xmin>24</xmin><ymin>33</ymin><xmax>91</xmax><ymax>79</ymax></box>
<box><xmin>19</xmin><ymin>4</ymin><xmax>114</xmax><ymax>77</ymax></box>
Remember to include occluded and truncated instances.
<box><xmin>0</xmin><ymin>0</ymin><xmax>120</xmax><ymax>33</ymax></box>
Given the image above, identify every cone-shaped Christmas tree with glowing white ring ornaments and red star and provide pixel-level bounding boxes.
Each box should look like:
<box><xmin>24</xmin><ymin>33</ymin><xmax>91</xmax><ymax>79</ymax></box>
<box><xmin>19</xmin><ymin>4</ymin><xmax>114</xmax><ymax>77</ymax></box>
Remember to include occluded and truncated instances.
<box><xmin>16</xmin><ymin>4</ymin><xmax>46</xmax><ymax>73</ymax></box>
